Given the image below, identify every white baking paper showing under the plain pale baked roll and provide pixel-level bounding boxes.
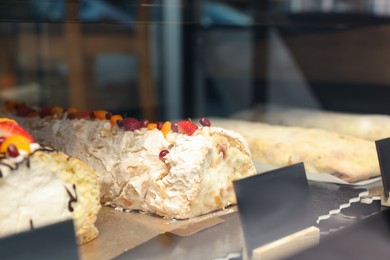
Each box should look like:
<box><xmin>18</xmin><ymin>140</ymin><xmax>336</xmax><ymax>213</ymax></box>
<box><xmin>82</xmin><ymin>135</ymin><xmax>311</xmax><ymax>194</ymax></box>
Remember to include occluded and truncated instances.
<box><xmin>253</xmin><ymin>161</ymin><xmax>381</xmax><ymax>186</ymax></box>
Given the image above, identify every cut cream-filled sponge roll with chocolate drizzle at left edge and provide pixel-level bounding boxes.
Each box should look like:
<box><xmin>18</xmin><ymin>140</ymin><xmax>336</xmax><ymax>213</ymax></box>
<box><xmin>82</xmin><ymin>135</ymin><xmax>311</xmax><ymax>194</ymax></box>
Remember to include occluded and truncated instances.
<box><xmin>0</xmin><ymin>118</ymin><xmax>100</xmax><ymax>244</ymax></box>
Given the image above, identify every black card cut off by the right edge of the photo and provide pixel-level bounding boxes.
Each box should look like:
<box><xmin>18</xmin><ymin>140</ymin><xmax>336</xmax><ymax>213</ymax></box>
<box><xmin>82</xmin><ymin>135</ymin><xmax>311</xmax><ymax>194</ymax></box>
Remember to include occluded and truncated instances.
<box><xmin>375</xmin><ymin>138</ymin><xmax>390</xmax><ymax>198</ymax></box>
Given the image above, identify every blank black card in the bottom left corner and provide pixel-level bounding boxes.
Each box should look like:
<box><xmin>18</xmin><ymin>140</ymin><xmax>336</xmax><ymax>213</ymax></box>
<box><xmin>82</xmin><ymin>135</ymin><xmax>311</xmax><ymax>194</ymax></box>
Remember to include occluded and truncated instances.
<box><xmin>0</xmin><ymin>220</ymin><xmax>79</xmax><ymax>260</ymax></box>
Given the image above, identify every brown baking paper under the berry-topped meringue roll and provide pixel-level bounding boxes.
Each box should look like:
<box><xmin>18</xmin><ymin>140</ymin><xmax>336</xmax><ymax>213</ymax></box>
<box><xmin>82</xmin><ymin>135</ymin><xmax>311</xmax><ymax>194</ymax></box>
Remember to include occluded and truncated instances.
<box><xmin>79</xmin><ymin>206</ymin><xmax>237</xmax><ymax>260</ymax></box>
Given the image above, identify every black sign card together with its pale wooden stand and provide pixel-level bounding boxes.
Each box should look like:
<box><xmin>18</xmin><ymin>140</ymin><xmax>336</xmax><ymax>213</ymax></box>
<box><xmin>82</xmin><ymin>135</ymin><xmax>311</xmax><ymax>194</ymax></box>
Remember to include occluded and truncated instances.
<box><xmin>234</xmin><ymin>163</ymin><xmax>320</xmax><ymax>259</ymax></box>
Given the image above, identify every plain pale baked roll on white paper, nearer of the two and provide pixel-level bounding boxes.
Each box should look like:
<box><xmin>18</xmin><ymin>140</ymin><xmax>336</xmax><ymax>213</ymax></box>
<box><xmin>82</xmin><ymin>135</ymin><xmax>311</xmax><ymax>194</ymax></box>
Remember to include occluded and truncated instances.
<box><xmin>212</xmin><ymin>118</ymin><xmax>380</xmax><ymax>183</ymax></box>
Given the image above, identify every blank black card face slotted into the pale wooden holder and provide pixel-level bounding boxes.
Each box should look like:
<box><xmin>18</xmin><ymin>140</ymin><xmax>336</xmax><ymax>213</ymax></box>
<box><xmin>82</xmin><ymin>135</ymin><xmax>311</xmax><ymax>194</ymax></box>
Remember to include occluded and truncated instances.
<box><xmin>234</xmin><ymin>163</ymin><xmax>315</xmax><ymax>252</ymax></box>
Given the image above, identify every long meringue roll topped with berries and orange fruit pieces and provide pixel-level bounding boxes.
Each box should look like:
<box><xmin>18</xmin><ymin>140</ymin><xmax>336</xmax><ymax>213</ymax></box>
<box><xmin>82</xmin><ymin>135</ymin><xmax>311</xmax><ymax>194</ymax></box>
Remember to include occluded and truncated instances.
<box><xmin>1</xmin><ymin>103</ymin><xmax>256</xmax><ymax>219</ymax></box>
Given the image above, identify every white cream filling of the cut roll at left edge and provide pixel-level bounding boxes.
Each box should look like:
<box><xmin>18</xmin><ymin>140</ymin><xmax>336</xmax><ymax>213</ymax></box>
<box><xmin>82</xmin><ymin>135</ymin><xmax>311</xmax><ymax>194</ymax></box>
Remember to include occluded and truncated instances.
<box><xmin>0</xmin><ymin>153</ymin><xmax>72</xmax><ymax>236</ymax></box>
